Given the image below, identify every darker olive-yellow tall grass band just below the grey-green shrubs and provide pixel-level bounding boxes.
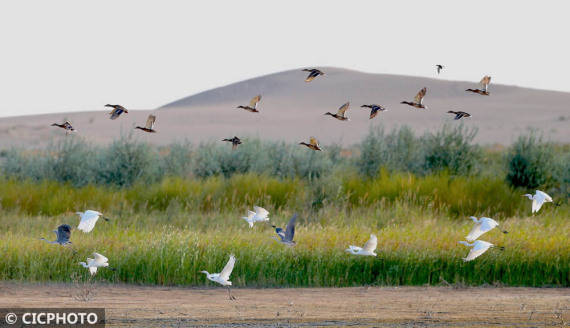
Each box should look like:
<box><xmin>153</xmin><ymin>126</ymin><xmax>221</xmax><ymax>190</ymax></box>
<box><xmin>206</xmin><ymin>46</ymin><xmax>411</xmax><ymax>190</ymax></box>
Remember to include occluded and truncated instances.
<box><xmin>0</xmin><ymin>170</ymin><xmax>556</xmax><ymax>218</ymax></box>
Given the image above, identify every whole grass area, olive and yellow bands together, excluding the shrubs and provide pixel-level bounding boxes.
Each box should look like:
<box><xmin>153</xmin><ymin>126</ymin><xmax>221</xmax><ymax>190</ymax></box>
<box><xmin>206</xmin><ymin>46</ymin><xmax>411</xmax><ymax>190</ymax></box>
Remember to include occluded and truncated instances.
<box><xmin>0</xmin><ymin>174</ymin><xmax>570</xmax><ymax>287</ymax></box>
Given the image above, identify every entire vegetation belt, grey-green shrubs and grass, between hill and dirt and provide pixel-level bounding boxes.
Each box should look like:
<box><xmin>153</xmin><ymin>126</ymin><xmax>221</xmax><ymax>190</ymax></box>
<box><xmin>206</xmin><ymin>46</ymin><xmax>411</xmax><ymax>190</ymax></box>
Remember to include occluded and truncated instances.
<box><xmin>0</xmin><ymin>125</ymin><xmax>570</xmax><ymax>287</ymax></box>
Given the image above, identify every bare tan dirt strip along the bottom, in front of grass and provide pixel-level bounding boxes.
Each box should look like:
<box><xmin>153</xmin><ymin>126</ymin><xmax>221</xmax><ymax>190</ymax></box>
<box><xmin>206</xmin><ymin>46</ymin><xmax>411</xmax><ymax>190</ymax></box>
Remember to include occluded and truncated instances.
<box><xmin>0</xmin><ymin>283</ymin><xmax>570</xmax><ymax>327</ymax></box>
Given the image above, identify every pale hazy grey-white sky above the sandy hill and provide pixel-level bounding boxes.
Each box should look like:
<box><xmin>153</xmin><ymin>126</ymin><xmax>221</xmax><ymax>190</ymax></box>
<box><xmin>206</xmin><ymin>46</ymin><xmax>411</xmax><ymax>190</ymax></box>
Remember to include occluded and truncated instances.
<box><xmin>0</xmin><ymin>0</ymin><xmax>570</xmax><ymax>116</ymax></box>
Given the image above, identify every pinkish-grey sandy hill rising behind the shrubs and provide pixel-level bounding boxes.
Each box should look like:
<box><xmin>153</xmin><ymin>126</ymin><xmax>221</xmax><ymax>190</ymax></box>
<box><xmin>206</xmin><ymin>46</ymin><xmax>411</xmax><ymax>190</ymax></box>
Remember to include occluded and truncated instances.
<box><xmin>0</xmin><ymin>67</ymin><xmax>570</xmax><ymax>148</ymax></box>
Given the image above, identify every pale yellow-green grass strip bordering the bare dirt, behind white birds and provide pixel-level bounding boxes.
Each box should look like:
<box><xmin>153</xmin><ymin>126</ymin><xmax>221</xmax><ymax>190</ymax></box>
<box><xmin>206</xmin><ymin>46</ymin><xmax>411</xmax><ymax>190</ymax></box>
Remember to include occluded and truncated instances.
<box><xmin>0</xmin><ymin>208</ymin><xmax>570</xmax><ymax>287</ymax></box>
